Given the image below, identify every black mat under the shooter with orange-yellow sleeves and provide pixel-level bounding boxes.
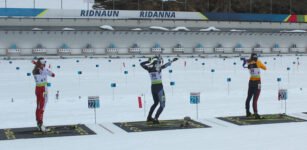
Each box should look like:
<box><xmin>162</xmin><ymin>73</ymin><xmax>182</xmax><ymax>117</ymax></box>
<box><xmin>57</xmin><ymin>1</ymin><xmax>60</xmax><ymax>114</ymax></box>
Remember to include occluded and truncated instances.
<box><xmin>218</xmin><ymin>114</ymin><xmax>306</xmax><ymax>125</ymax></box>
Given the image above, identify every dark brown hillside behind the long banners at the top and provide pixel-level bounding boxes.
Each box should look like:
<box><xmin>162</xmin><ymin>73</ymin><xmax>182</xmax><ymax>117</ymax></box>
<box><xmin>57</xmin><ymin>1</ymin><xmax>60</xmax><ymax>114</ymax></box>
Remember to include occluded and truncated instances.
<box><xmin>96</xmin><ymin>0</ymin><xmax>307</xmax><ymax>14</ymax></box>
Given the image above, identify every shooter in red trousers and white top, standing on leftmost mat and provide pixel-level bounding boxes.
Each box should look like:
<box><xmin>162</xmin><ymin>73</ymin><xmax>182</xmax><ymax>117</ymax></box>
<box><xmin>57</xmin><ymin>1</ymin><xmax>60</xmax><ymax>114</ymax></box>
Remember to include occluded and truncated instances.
<box><xmin>32</xmin><ymin>58</ymin><xmax>55</xmax><ymax>132</ymax></box>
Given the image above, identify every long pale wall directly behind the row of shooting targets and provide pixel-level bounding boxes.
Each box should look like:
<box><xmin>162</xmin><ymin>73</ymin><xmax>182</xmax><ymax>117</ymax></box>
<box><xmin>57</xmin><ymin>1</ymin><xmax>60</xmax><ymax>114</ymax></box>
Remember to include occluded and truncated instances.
<box><xmin>0</xmin><ymin>31</ymin><xmax>307</xmax><ymax>55</ymax></box>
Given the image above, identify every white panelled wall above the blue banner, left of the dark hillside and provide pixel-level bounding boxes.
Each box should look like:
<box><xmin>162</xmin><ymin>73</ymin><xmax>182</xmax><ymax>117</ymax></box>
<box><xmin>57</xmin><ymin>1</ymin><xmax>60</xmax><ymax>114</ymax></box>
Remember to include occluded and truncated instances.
<box><xmin>0</xmin><ymin>0</ymin><xmax>93</xmax><ymax>9</ymax></box>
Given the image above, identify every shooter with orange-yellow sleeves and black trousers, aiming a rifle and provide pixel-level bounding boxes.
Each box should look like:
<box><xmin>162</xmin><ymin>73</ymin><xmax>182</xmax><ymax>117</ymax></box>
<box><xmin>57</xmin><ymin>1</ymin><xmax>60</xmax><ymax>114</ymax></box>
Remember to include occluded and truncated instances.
<box><xmin>243</xmin><ymin>53</ymin><xmax>266</xmax><ymax>119</ymax></box>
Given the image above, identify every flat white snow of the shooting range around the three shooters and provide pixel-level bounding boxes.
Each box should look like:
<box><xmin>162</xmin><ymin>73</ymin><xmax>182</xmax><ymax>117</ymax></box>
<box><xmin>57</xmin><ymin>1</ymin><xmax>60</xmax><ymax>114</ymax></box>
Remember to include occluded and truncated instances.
<box><xmin>0</xmin><ymin>56</ymin><xmax>307</xmax><ymax>150</ymax></box>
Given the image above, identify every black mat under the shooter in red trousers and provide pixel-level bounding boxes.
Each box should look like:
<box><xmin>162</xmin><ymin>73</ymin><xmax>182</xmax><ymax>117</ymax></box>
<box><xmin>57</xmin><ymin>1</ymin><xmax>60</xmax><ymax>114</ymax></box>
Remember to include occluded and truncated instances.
<box><xmin>0</xmin><ymin>124</ymin><xmax>96</xmax><ymax>140</ymax></box>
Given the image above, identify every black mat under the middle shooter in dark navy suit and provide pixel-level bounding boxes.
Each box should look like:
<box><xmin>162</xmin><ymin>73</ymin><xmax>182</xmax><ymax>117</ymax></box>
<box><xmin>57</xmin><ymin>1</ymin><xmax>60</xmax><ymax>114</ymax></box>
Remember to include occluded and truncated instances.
<box><xmin>114</xmin><ymin>119</ymin><xmax>210</xmax><ymax>132</ymax></box>
